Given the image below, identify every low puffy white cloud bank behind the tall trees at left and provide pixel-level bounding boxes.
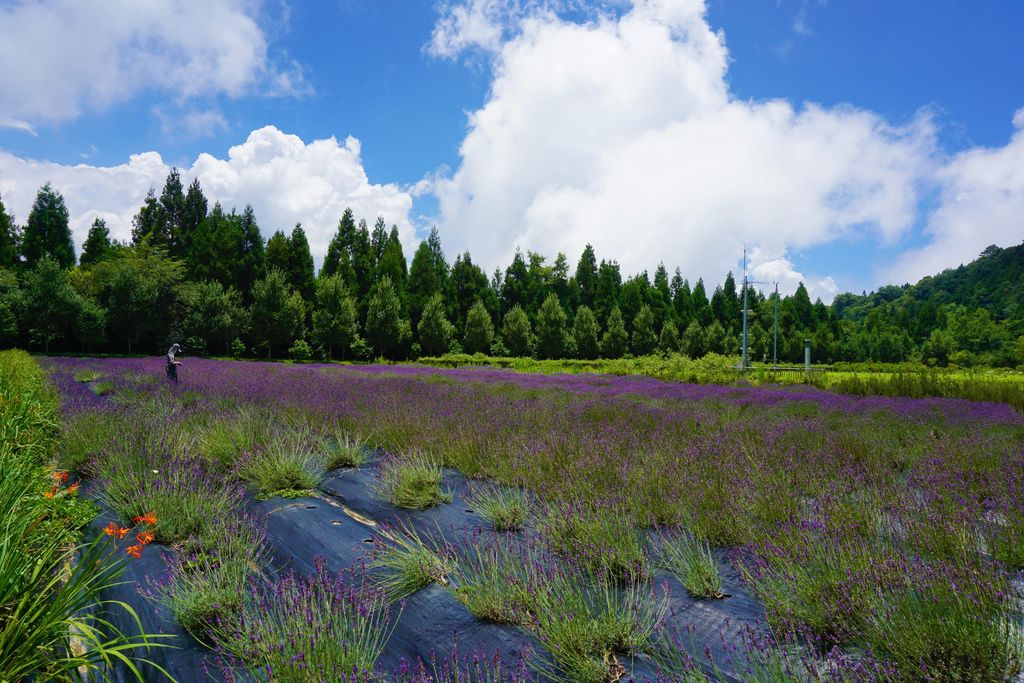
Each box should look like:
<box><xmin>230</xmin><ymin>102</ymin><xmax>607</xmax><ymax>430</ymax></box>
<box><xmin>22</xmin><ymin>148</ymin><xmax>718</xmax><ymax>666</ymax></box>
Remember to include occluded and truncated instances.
<box><xmin>0</xmin><ymin>126</ymin><xmax>417</xmax><ymax>262</ymax></box>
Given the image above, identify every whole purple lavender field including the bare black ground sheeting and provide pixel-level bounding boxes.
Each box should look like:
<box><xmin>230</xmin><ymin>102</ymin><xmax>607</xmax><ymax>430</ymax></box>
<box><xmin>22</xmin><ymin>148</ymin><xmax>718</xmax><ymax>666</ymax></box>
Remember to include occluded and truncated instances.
<box><xmin>45</xmin><ymin>358</ymin><xmax>1024</xmax><ymax>683</ymax></box>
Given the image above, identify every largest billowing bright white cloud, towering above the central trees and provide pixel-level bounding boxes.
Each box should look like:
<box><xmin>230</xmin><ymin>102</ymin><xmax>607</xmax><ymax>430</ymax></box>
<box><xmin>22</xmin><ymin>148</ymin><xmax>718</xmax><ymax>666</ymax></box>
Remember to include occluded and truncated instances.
<box><xmin>434</xmin><ymin>0</ymin><xmax>935</xmax><ymax>298</ymax></box>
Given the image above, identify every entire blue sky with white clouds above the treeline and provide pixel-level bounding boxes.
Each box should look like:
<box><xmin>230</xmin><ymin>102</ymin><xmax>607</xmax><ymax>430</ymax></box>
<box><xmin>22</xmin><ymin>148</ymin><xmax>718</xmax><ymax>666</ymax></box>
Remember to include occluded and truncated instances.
<box><xmin>0</xmin><ymin>0</ymin><xmax>1024</xmax><ymax>301</ymax></box>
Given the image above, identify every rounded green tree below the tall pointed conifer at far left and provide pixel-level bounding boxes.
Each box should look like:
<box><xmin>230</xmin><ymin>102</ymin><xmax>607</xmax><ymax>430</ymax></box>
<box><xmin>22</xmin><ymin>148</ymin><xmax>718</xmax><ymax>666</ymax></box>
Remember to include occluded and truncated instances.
<box><xmin>24</xmin><ymin>254</ymin><xmax>82</xmax><ymax>353</ymax></box>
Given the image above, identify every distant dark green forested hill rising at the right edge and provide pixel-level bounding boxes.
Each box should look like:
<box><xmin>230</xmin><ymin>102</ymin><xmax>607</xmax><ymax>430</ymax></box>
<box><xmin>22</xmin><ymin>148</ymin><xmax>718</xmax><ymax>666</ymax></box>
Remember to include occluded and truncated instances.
<box><xmin>833</xmin><ymin>244</ymin><xmax>1024</xmax><ymax>330</ymax></box>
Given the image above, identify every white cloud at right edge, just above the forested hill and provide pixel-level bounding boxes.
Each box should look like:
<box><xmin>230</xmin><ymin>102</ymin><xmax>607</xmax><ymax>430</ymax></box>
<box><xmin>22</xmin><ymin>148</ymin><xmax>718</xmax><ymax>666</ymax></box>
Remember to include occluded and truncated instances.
<box><xmin>885</xmin><ymin>109</ymin><xmax>1024</xmax><ymax>284</ymax></box>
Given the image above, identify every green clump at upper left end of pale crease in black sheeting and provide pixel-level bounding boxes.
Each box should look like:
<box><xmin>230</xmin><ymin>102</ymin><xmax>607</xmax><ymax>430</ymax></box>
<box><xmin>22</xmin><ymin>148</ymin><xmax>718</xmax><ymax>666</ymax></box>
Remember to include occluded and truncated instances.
<box><xmin>239</xmin><ymin>430</ymin><xmax>326</xmax><ymax>498</ymax></box>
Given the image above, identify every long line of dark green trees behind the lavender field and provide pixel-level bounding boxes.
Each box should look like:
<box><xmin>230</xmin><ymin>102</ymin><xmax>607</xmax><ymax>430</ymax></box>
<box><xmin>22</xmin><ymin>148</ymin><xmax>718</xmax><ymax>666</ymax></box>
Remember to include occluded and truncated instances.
<box><xmin>0</xmin><ymin>169</ymin><xmax>1024</xmax><ymax>366</ymax></box>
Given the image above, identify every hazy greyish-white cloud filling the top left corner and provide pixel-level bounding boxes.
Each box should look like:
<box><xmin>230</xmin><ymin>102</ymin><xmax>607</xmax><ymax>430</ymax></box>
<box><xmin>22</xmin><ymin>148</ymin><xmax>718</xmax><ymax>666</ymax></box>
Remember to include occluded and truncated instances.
<box><xmin>0</xmin><ymin>0</ymin><xmax>309</xmax><ymax>128</ymax></box>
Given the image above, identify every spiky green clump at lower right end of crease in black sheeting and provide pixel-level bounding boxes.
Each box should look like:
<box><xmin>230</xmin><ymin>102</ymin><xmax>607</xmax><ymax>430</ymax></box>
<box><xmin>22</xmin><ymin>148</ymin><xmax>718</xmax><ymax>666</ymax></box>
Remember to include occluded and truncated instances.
<box><xmin>369</xmin><ymin>524</ymin><xmax>456</xmax><ymax>601</ymax></box>
